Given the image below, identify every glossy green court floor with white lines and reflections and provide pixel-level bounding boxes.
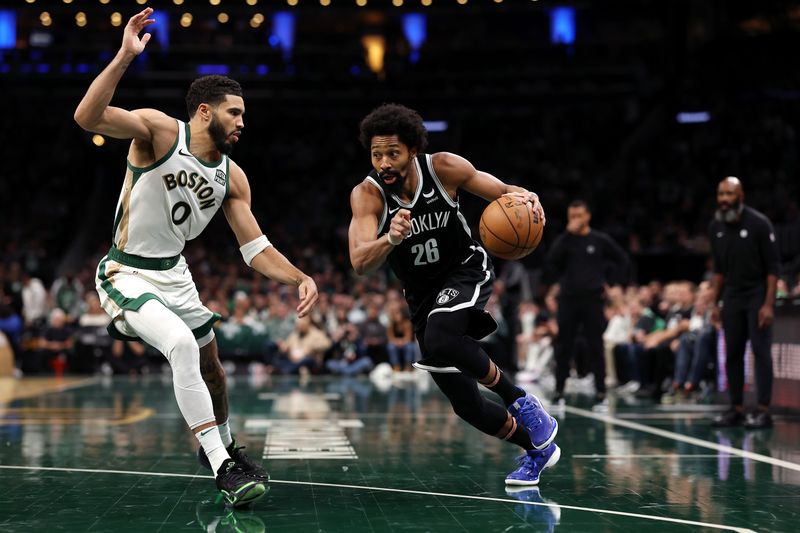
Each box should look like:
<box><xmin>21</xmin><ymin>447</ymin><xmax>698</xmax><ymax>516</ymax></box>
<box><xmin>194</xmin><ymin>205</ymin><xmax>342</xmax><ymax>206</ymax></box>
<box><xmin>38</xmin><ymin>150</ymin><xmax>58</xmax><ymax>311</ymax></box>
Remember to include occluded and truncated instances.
<box><xmin>0</xmin><ymin>374</ymin><xmax>800</xmax><ymax>532</ymax></box>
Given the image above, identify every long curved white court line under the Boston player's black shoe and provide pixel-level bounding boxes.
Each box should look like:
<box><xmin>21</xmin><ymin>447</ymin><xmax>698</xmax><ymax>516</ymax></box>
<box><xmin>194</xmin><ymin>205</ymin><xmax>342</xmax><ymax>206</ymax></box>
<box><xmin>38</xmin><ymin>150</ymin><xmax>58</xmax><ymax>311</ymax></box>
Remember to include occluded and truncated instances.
<box><xmin>0</xmin><ymin>465</ymin><xmax>755</xmax><ymax>533</ymax></box>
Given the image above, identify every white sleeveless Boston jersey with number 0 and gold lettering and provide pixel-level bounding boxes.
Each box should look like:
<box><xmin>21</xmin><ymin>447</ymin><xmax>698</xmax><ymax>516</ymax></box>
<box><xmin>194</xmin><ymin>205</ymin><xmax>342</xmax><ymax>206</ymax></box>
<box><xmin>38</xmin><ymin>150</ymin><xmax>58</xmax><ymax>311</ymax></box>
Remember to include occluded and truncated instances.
<box><xmin>114</xmin><ymin>120</ymin><xmax>229</xmax><ymax>257</ymax></box>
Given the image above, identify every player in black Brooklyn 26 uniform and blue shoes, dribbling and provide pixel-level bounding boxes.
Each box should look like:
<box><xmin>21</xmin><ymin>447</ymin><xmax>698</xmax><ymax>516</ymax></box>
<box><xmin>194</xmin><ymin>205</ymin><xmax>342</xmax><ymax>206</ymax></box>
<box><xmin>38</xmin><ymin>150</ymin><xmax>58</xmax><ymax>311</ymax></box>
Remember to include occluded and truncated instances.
<box><xmin>349</xmin><ymin>104</ymin><xmax>561</xmax><ymax>485</ymax></box>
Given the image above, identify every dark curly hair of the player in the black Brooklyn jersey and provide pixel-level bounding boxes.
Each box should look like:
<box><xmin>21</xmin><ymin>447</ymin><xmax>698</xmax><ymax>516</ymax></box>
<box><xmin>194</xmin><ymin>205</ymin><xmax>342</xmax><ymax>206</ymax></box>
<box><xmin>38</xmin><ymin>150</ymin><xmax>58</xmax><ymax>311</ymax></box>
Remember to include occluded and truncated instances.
<box><xmin>359</xmin><ymin>104</ymin><xmax>428</xmax><ymax>152</ymax></box>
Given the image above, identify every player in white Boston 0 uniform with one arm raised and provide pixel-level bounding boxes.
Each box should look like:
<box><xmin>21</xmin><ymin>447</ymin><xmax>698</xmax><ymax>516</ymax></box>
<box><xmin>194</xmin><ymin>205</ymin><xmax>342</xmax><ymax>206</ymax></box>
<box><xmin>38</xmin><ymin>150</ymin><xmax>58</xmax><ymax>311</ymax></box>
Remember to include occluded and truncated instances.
<box><xmin>75</xmin><ymin>8</ymin><xmax>317</xmax><ymax>507</ymax></box>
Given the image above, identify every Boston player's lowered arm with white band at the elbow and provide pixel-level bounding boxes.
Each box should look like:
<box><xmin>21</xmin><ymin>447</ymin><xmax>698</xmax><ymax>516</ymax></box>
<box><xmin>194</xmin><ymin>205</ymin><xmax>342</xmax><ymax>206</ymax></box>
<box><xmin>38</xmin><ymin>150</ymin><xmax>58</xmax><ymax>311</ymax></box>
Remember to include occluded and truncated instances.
<box><xmin>222</xmin><ymin>161</ymin><xmax>319</xmax><ymax>316</ymax></box>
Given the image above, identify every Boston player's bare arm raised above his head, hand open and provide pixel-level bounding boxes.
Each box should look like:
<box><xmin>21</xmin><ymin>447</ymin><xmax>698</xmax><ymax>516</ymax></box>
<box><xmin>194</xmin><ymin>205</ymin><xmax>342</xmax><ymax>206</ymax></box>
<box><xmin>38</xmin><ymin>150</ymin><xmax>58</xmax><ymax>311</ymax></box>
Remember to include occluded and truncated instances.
<box><xmin>75</xmin><ymin>7</ymin><xmax>172</xmax><ymax>142</ymax></box>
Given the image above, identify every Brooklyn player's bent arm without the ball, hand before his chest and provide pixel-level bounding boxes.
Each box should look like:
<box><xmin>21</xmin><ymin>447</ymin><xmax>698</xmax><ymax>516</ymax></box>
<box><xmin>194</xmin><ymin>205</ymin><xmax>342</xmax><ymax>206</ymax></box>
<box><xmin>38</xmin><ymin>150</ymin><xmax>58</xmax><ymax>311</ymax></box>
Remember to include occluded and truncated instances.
<box><xmin>347</xmin><ymin>182</ymin><xmax>411</xmax><ymax>275</ymax></box>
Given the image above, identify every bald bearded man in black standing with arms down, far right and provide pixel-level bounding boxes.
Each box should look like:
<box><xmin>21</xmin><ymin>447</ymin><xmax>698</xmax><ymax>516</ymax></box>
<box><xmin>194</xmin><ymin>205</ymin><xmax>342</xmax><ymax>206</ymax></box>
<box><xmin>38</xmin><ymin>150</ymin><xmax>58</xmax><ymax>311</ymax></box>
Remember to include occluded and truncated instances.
<box><xmin>709</xmin><ymin>176</ymin><xmax>779</xmax><ymax>429</ymax></box>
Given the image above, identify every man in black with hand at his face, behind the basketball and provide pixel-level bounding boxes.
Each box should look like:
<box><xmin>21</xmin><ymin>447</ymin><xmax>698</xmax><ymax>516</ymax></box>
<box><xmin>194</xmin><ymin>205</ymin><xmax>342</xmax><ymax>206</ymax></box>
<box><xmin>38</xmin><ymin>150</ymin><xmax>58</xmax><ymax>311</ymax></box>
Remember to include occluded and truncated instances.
<box><xmin>547</xmin><ymin>200</ymin><xmax>628</xmax><ymax>404</ymax></box>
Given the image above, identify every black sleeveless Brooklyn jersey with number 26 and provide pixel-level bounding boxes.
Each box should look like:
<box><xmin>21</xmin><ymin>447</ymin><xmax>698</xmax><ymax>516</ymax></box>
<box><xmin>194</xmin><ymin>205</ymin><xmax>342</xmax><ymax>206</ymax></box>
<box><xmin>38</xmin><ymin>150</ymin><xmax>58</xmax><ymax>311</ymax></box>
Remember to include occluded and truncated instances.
<box><xmin>366</xmin><ymin>154</ymin><xmax>478</xmax><ymax>290</ymax></box>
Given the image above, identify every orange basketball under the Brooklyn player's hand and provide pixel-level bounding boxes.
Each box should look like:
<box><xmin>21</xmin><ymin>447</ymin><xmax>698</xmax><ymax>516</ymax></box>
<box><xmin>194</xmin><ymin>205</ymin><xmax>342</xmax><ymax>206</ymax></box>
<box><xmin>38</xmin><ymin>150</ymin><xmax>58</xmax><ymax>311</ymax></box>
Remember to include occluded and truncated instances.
<box><xmin>479</xmin><ymin>196</ymin><xmax>544</xmax><ymax>259</ymax></box>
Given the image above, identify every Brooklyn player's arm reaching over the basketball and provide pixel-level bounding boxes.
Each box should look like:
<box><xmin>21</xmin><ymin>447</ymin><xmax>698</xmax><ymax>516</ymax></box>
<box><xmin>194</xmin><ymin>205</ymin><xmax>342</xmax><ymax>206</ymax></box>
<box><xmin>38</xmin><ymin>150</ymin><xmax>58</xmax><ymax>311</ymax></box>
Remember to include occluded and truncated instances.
<box><xmin>432</xmin><ymin>152</ymin><xmax>545</xmax><ymax>224</ymax></box>
